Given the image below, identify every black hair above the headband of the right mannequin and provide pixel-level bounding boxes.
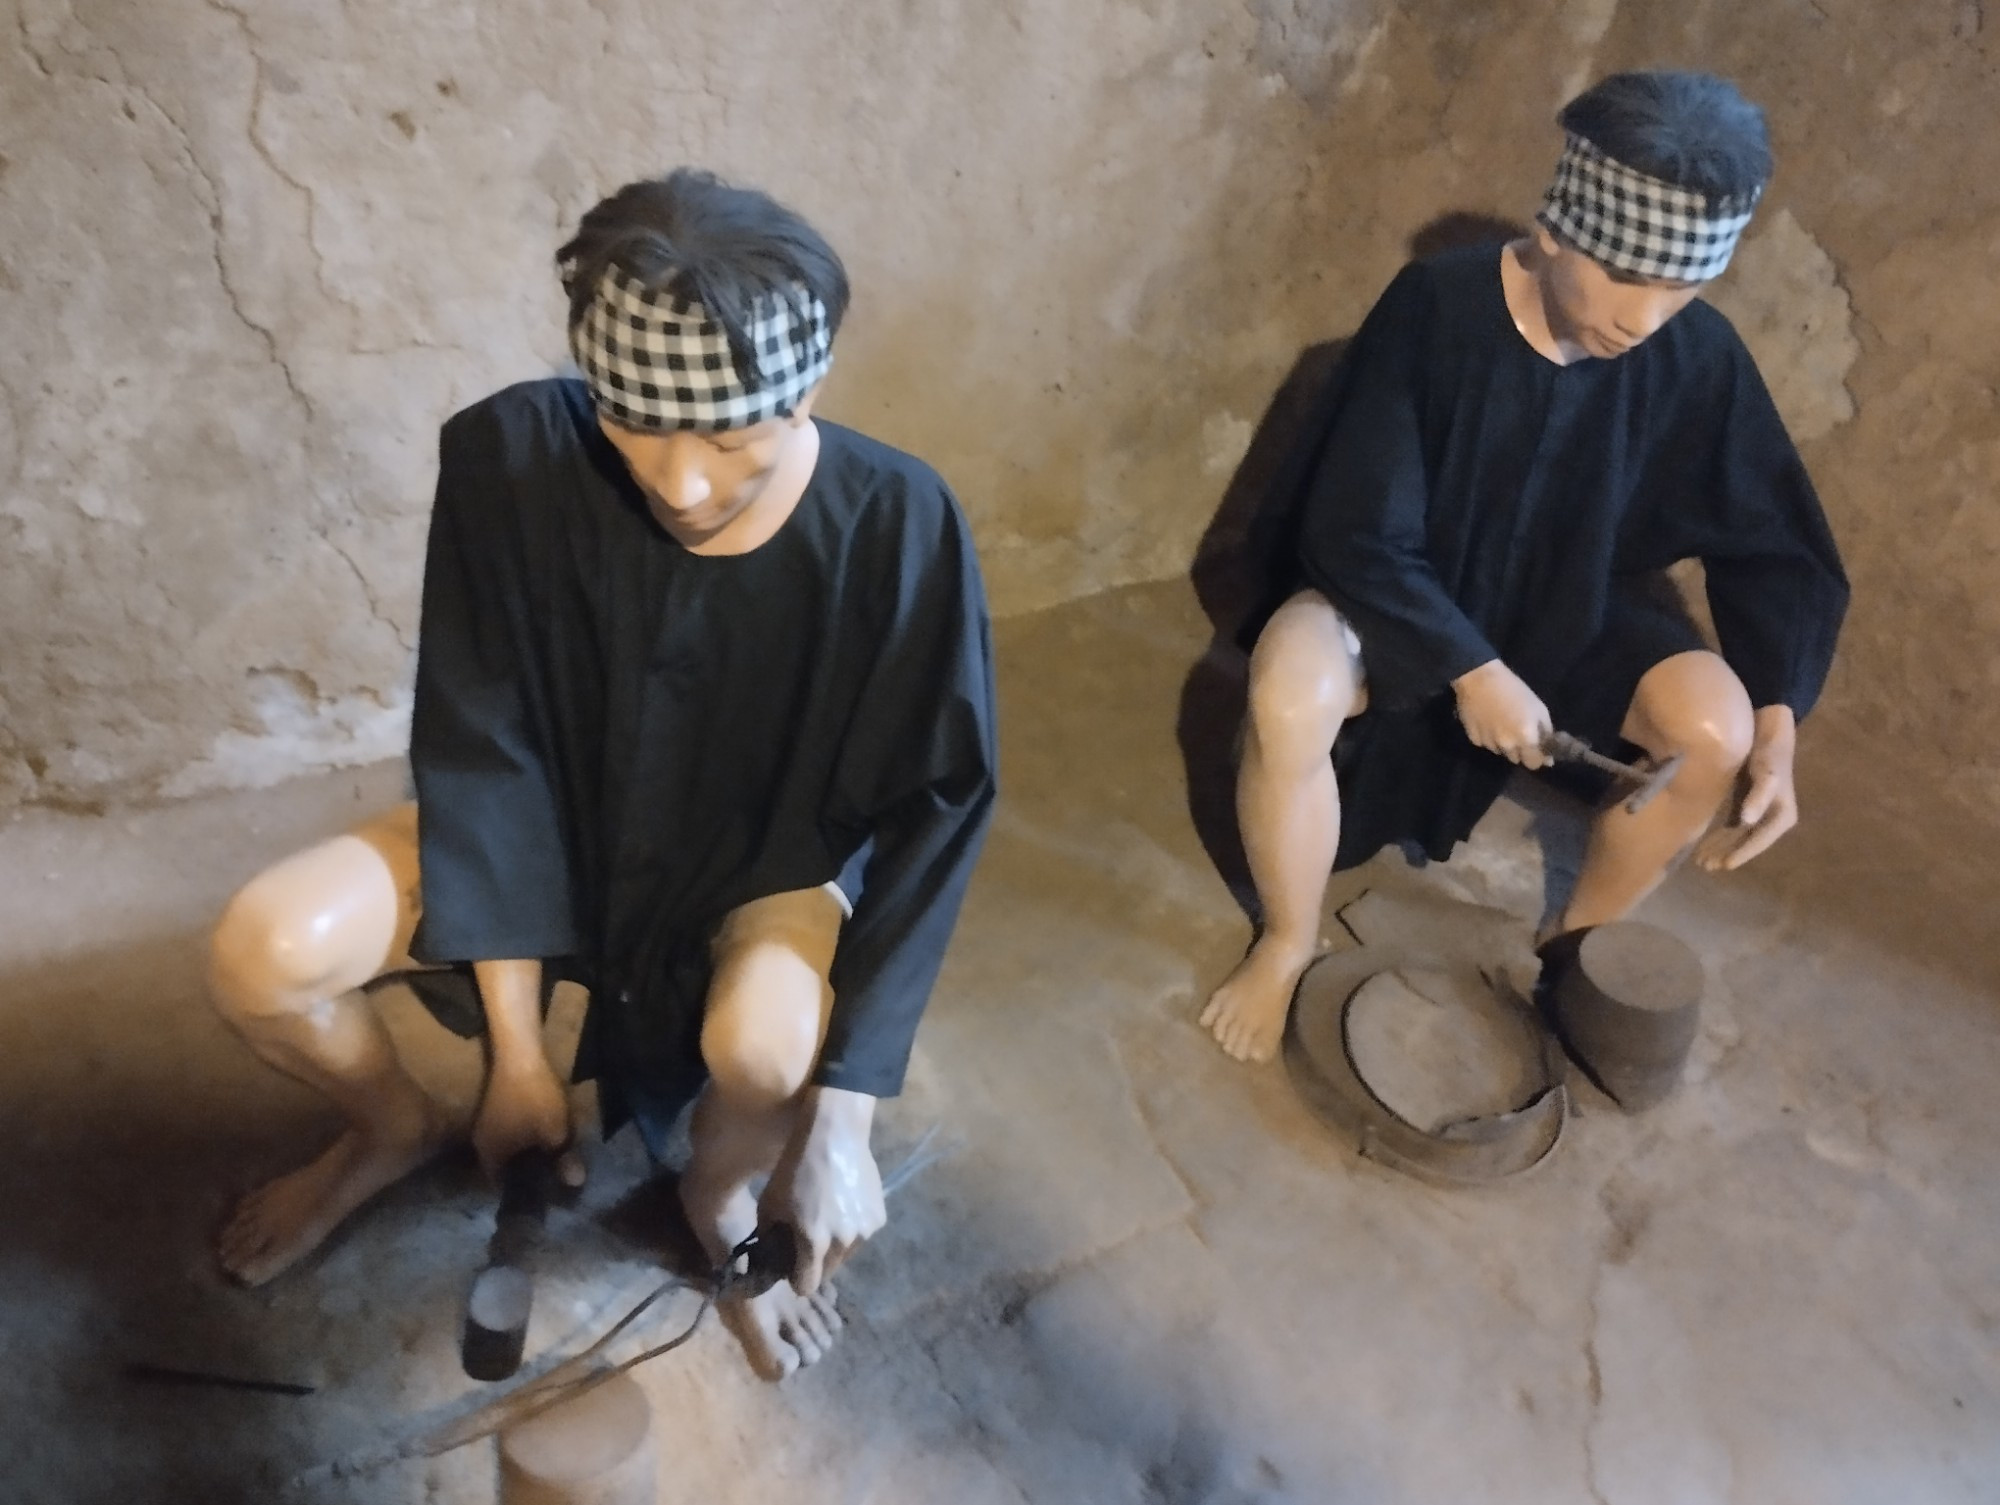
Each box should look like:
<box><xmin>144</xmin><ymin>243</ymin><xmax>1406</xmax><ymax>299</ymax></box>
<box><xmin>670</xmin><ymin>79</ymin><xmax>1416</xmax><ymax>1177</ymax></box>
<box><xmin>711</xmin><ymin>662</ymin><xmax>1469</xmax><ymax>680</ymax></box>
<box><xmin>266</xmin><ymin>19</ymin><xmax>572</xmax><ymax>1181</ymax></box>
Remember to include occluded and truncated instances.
<box><xmin>1556</xmin><ymin>70</ymin><xmax>1772</xmax><ymax>198</ymax></box>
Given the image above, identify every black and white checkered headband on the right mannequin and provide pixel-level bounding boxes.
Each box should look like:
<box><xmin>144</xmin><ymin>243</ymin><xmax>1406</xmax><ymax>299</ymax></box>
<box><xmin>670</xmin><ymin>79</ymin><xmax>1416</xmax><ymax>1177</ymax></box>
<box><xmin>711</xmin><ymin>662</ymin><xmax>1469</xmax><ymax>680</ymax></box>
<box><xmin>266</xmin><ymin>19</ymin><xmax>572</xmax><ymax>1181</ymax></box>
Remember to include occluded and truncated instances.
<box><xmin>1536</xmin><ymin>134</ymin><xmax>1764</xmax><ymax>282</ymax></box>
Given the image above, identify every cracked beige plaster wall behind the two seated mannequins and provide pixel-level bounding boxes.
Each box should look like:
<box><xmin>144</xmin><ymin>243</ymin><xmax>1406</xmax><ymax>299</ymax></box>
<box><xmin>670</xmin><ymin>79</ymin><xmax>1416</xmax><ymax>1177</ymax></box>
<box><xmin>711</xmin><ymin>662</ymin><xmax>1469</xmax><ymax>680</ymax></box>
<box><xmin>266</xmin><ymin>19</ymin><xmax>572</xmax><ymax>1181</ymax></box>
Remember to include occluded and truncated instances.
<box><xmin>0</xmin><ymin>0</ymin><xmax>2000</xmax><ymax>813</ymax></box>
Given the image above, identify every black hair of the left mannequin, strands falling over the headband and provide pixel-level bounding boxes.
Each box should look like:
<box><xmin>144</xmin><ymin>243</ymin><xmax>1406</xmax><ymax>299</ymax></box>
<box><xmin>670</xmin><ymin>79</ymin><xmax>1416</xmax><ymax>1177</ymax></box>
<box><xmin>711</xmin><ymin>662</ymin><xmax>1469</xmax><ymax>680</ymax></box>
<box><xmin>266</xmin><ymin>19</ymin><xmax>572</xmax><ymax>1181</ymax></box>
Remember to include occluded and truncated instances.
<box><xmin>556</xmin><ymin>168</ymin><xmax>848</xmax><ymax>382</ymax></box>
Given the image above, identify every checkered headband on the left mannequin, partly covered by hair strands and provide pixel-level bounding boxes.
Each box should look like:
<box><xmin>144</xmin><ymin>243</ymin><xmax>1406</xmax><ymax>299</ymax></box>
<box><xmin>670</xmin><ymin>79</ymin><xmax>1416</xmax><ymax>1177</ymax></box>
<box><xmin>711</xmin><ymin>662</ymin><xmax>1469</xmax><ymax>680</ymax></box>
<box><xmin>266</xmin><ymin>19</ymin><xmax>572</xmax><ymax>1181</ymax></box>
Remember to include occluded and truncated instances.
<box><xmin>570</xmin><ymin>266</ymin><xmax>834</xmax><ymax>432</ymax></box>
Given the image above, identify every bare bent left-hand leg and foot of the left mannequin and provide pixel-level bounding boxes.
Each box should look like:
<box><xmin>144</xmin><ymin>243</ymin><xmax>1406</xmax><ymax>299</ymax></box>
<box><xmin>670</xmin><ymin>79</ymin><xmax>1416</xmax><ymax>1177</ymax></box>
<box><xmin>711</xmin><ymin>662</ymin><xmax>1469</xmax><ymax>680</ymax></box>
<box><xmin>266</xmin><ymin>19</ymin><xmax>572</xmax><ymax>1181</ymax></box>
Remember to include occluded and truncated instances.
<box><xmin>210</xmin><ymin>807</ymin><xmax>444</xmax><ymax>1285</ymax></box>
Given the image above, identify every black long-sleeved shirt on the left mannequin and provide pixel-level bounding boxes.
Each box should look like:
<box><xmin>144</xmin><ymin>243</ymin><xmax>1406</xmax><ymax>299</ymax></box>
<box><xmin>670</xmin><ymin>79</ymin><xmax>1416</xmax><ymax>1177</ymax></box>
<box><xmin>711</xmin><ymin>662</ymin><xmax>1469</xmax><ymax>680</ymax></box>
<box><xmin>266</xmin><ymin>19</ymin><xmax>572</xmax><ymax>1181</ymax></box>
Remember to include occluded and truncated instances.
<box><xmin>410</xmin><ymin>380</ymin><xmax>996</xmax><ymax>1137</ymax></box>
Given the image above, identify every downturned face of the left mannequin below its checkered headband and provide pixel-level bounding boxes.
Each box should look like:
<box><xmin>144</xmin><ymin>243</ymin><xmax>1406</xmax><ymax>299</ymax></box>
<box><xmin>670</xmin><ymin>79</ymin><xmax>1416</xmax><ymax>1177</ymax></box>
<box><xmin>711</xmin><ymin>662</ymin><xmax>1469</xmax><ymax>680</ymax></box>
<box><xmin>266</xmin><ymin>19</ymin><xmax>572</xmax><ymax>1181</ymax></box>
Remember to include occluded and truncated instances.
<box><xmin>598</xmin><ymin>388</ymin><xmax>818</xmax><ymax>548</ymax></box>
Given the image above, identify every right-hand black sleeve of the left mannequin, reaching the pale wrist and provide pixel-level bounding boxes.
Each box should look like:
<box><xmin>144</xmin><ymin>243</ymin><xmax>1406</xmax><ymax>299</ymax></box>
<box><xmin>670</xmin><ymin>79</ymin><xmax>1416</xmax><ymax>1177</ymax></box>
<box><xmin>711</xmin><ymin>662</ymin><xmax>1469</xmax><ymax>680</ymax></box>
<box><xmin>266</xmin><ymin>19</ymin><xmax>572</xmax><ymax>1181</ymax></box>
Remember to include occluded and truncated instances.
<box><xmin>814</xmin><ymin>482</ymin><xmax>998</xmax><ymax>1097</ymax></box>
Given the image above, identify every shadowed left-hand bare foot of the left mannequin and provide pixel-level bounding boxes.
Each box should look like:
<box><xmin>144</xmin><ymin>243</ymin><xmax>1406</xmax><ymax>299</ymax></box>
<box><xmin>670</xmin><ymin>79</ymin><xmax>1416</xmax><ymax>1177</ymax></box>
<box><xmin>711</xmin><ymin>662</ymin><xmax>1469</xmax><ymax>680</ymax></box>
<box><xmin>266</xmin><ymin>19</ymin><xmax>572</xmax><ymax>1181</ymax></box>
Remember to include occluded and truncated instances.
<box><xmin>216</xmin><ymin>1099</ymin><xmax>446</xmax><ymax>1285</ymax></box>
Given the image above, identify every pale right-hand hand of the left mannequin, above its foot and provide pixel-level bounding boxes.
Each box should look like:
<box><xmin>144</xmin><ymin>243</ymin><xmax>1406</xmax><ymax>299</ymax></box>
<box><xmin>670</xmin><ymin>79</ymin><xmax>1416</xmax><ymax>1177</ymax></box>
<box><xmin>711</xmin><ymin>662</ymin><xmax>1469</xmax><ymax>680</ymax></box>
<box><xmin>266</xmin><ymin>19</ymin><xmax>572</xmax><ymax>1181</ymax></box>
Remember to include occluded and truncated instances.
<box><xmin>756</xmin><ymin>1087</ymin><xmax>888</xmax><ymax>1297</ymax></box>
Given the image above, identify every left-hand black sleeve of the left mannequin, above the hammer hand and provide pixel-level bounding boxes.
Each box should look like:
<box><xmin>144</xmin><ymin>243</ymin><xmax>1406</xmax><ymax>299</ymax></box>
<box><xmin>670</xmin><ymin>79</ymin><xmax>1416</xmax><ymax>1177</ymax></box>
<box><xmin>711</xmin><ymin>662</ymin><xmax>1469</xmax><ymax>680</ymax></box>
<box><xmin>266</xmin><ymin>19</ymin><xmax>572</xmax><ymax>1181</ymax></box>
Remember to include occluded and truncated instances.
<box><xmin>410</xmin><ymin>408</ymin><xmax>578</xmax><ymax>963</ymax></box>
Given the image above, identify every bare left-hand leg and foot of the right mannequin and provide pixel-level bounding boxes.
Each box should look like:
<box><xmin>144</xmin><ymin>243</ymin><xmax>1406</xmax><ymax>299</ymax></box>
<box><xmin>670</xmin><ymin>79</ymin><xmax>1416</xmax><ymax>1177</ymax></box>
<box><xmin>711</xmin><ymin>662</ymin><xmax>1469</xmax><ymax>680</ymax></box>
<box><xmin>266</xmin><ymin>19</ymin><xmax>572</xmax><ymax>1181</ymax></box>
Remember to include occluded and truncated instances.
<box><xmin>1200</xmin><ymin>590</ymin><xmax>1366</xmax><ymax>1061</ymax></box>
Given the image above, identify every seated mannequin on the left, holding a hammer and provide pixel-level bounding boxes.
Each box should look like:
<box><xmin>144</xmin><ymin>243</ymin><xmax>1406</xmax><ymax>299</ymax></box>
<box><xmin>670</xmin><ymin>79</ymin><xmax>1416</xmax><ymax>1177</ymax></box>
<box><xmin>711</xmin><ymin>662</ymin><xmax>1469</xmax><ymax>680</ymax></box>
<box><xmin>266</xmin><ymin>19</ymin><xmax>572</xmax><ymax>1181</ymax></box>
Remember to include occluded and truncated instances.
<box><xmin>212</xmin><ymin>170</ymin><xmax>994</xmax><ymax>1379</ymax></box>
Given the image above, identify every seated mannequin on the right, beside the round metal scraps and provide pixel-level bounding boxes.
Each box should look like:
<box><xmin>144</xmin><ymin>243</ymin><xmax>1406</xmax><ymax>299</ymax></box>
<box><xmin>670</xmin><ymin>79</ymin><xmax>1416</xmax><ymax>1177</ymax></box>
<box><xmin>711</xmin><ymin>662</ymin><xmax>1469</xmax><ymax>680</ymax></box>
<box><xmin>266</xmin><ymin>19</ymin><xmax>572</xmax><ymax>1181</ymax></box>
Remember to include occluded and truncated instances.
<box><xmin>1202</xmin><ymin>72</ymin><xmax>1848</xmax><ymax>1061</ymax></box>
